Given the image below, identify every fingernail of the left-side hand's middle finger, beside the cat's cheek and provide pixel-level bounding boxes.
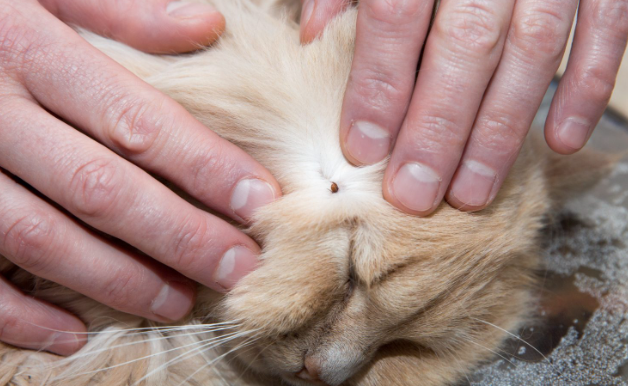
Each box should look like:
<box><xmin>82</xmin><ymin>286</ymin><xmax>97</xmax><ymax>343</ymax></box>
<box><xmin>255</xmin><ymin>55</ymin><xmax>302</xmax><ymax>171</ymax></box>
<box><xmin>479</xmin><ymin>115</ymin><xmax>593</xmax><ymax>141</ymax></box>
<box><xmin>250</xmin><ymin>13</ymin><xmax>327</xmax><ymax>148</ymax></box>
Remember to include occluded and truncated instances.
<box><xmin>214</xmin><ymin>246</ymin><xmax>257</xmax><ymax>290</ymax></box>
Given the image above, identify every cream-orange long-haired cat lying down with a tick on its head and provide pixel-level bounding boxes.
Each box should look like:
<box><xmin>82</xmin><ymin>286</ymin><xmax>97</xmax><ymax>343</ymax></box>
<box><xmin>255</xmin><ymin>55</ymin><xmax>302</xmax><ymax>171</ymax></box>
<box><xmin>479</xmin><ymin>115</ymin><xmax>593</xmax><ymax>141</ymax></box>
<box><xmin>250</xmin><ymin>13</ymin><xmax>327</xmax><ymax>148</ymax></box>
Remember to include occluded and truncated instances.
<box><xmin>0</xmin><ymin>0</ymin><xmax>608</xmax><ymax>386</ymax></box>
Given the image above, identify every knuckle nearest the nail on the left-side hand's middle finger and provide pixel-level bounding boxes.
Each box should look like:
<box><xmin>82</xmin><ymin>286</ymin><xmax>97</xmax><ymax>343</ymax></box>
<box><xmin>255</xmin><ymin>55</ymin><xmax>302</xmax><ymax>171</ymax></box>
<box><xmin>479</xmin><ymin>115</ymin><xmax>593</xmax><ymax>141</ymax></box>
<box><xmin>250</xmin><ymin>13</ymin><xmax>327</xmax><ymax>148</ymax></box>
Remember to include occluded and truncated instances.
<box><xmin>170</xmin><ymin>216</ymin><xmax>211</xmax><ymax>273</ymax></box>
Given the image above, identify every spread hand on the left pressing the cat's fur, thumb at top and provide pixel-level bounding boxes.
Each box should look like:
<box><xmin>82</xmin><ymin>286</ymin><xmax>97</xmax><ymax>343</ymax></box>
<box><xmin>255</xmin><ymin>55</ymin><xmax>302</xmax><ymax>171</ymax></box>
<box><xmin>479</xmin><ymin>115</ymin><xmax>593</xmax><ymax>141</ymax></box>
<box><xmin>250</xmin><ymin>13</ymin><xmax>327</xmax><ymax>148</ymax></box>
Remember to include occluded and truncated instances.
<box><xmin>0</xmin><ymin>0</ymin><xmax>281</xmax><ymax>355</ymax></box>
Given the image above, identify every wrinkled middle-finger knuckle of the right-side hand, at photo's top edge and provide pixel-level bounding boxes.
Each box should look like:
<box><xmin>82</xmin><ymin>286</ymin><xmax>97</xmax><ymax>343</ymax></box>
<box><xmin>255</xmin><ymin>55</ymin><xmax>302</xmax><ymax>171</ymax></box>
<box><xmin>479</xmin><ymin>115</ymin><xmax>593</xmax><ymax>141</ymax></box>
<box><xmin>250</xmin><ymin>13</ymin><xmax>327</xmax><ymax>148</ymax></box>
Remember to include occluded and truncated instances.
<box><xmin>434</xmin><ymin>0</ymin><xmax>504</xmax><ymax>55</ymax></box>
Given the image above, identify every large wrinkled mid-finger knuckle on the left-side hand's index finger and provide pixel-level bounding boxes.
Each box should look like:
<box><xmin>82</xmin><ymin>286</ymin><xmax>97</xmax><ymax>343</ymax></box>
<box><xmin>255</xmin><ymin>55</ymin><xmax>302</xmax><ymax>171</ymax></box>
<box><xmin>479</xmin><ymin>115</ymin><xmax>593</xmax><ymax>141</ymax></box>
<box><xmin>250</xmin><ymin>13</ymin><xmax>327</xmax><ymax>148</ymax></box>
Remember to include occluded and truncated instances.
<box><xmin>106</xmin><ymin>96</ymin><xmax>160</xmax><ymax>156</ymax></box>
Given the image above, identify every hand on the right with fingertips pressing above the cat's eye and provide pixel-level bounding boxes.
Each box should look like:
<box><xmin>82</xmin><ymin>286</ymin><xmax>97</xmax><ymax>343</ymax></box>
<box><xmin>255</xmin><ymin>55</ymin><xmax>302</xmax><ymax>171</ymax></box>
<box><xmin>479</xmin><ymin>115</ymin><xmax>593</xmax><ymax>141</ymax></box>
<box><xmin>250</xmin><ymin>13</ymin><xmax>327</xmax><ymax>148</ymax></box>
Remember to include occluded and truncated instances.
<box><xmin>301</xmin><ymin>0</ymin><xmax>628</xmax><ymax>215</ymax></box>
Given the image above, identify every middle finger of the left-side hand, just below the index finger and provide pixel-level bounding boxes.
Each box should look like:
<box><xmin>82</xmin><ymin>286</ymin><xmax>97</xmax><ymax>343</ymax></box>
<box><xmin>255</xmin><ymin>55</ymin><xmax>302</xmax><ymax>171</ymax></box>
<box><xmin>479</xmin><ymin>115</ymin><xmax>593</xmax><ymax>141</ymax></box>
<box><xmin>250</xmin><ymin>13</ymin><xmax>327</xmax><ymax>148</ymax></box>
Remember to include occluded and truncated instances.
<box><xmin>0</xmin><ymin>98</ymin><xmax>259</xmax><ymax>290</ymax></box>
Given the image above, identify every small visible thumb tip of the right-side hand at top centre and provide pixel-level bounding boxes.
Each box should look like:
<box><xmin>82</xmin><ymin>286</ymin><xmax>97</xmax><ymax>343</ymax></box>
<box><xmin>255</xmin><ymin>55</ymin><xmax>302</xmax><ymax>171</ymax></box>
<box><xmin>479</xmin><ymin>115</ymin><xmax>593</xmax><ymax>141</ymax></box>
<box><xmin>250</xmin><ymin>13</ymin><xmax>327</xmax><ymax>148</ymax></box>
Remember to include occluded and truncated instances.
<box><xmin>300</xmin><ymin>0</ymin><xmax>351</xmax><ymax>44</ymax></box>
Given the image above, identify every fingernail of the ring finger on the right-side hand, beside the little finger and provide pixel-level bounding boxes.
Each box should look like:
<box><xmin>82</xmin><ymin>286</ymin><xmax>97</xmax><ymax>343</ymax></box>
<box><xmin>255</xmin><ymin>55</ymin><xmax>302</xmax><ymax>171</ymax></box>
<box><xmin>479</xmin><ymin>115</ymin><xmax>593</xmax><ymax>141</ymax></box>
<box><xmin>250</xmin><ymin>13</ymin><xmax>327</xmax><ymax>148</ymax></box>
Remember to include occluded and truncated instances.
<box><xmin>451</xmin><ymin>160</ymin><xmax>497</xmax><ymax>207</ymax></box>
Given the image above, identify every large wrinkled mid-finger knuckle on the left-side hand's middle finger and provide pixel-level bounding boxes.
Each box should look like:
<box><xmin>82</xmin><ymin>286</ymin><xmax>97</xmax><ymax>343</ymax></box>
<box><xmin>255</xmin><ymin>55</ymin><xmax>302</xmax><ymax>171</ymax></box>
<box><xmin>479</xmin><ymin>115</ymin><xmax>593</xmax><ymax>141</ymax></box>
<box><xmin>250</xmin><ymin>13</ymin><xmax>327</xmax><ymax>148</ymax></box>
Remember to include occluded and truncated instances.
<box><xmin>69</xmin><ymin>158</ymin><xmax>122</xmax><ymax>217</ymax></box>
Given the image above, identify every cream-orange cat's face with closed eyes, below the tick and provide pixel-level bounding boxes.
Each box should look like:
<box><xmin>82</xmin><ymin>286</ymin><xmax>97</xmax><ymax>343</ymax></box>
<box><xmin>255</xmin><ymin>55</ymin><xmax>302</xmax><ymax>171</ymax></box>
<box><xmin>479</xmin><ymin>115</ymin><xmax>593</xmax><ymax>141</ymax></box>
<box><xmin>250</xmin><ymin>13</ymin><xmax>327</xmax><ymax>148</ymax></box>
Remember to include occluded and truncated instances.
<box><xmin>220</xmin><ymin>160</ymin><xmax>544</xmax><ymax>385</ymax></box>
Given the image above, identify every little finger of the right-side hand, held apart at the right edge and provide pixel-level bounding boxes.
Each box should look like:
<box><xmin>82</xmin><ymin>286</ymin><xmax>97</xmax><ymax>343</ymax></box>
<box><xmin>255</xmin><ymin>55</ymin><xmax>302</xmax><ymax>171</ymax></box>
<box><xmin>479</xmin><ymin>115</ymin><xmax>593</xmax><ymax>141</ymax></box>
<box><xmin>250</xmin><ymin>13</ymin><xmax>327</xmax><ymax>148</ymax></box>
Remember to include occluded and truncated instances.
<box><xmin>545</xmin><ymin>0</ymin><xmax>628</xmax><ymax>154</ymax></box>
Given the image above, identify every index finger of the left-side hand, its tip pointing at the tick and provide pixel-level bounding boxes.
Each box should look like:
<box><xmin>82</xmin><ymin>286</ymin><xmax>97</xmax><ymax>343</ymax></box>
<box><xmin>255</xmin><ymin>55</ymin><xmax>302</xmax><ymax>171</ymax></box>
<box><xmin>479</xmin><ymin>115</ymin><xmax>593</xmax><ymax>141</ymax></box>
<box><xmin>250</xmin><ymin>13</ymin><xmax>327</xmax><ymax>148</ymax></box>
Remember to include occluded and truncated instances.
<box><xmin>12</xmin><ymin>4</ymin><xmax>281</xmax><ymax>222</ymax></box>
